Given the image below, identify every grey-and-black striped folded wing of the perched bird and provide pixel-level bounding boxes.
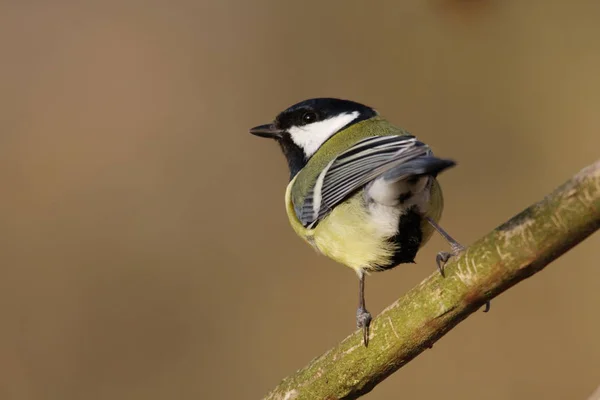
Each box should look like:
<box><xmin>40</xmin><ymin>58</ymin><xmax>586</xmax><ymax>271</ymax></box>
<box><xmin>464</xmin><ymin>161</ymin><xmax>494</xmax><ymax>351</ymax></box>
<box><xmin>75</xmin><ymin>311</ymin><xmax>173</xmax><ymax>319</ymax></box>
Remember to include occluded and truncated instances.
<box><xmin>295</xmin><ymin>135</ymin><xmax>431</xmax><ymax>227</ymax></box>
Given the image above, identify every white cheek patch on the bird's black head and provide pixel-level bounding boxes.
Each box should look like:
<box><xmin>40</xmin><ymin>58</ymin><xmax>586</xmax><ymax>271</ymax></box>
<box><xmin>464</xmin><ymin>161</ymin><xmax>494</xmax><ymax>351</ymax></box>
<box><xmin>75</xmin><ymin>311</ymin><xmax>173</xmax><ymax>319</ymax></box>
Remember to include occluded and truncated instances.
<box><xmin>288</xmin><ymin>111</ymin><xmax>360</xmax><ymax>158</ymax></box>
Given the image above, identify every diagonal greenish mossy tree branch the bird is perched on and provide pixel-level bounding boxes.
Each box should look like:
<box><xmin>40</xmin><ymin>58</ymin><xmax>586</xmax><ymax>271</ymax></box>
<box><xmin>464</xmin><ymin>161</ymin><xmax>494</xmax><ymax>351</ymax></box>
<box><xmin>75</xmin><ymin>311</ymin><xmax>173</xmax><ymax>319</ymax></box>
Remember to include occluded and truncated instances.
<box><xmin>266</xmin><ymin>160</ymin><xmax>600</xmax><ymax>400</ymax></box>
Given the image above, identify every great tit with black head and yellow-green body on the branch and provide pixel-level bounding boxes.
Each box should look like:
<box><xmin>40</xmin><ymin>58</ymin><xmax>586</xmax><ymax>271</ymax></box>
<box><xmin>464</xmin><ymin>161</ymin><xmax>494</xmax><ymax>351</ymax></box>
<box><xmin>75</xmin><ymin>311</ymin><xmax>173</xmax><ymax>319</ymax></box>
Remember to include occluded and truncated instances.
<box><xmin>250</xmin><ymin>98</ymin><xmax>474</xmax><ymax>346</ymax></box>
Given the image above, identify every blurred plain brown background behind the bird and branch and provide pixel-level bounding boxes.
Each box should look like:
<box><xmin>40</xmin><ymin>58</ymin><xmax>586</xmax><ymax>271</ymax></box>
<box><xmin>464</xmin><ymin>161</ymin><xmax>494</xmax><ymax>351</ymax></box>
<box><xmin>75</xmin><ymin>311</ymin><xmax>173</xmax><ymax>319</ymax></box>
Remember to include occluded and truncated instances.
<box><xmin>0</xmin><ymin>0</ymin><xmax>600</xmax><ymax>400</ymax></box>
